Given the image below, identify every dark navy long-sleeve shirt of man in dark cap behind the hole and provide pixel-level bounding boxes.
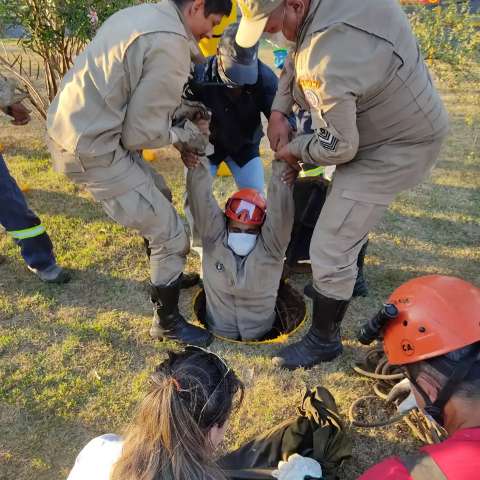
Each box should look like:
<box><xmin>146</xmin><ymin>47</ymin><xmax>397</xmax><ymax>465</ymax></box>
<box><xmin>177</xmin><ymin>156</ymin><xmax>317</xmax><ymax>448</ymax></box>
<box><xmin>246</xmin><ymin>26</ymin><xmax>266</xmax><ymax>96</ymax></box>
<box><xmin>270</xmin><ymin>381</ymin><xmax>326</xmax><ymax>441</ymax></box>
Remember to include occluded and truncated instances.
<box><xmin>189</xmin><ymin>57</ymin><xmax>278</xmax><ymax>167</ymax></box>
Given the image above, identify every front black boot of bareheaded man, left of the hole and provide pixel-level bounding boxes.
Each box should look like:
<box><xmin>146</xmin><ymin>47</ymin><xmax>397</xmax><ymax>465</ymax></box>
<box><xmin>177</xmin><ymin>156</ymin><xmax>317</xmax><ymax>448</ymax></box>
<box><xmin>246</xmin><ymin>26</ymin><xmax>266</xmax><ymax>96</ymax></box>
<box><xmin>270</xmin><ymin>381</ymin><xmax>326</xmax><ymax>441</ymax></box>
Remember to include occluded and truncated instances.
<box><xmin>150</xmin><ymin>277</ymin><xmax>213</xmax><ymax>347</ymax></box>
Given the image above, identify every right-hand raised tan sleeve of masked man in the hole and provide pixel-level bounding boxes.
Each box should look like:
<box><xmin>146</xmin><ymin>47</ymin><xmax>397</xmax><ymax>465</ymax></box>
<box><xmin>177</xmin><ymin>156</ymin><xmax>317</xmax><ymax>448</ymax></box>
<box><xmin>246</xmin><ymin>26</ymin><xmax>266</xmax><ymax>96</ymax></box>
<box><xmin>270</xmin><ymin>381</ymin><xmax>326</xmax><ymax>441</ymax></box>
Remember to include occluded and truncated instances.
<box><xmin>262</xmin><ymin>160</ymin><xmax>295</xmax><ymax>259</ymax></box>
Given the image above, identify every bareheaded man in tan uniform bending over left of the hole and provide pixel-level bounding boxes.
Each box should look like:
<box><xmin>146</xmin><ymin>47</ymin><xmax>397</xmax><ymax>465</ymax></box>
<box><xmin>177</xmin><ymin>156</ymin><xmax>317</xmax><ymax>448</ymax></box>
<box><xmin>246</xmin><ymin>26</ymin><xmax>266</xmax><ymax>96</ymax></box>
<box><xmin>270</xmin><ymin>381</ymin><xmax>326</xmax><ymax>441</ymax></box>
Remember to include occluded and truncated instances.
<box><xmin>47</xmin><ymin>0</ymin><xmax>231</xmax><ymax>345</ymax></box>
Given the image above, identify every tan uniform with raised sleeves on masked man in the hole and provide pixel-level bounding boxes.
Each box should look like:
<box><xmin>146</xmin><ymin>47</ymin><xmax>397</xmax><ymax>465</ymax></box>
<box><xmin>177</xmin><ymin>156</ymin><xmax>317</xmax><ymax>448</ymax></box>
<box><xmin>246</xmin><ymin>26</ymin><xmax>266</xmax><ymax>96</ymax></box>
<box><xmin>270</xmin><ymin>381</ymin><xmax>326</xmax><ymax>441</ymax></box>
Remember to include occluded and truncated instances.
<box><xmin>187</xmin><ymin>162</ymin><xmax>294</xmax><ymax>340</ymax></box>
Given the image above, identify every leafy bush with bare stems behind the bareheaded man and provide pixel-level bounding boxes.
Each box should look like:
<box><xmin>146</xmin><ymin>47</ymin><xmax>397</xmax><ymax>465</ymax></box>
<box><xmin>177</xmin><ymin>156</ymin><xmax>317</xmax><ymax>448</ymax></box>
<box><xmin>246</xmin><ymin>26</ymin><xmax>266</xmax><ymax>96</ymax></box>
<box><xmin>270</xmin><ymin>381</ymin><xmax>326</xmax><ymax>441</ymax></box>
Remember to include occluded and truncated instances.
<box><xmin>0</xmin><ymin>0</ymin><xmax>137</xmax><ymax>118</ymax></box>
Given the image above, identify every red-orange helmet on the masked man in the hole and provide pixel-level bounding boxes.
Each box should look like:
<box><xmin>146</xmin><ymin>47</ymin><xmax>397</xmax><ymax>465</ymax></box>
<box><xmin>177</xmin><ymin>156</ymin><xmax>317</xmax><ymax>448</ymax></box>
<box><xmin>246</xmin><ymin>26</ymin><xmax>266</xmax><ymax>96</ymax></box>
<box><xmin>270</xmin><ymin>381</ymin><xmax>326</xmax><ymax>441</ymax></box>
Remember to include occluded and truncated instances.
<box><xmin>225</xmin><ymin>188</ymin><xmax>267</xmax><ymax>225</ymax></box>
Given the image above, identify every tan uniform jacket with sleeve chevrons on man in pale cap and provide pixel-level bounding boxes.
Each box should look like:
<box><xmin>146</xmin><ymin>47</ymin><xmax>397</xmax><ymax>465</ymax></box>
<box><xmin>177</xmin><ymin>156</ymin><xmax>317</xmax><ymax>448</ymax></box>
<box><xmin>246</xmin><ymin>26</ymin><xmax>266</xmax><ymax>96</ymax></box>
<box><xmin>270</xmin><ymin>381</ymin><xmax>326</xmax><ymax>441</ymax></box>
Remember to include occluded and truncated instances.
<box><xmin>272</xmin><ymin>0</ymin><xmax>448</xmax><ymax>203</ymax></box>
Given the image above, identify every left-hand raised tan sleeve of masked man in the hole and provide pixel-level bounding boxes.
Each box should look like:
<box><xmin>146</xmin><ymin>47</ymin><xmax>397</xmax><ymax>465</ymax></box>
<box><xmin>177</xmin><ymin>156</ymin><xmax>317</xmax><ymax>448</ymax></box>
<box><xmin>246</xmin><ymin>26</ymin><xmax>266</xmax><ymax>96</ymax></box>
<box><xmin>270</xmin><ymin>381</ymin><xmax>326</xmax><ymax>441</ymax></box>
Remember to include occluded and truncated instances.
<box><xmin>187</xmin><ymin>157</ymin><xmax>226</xmax><ymax>242</ymax></box>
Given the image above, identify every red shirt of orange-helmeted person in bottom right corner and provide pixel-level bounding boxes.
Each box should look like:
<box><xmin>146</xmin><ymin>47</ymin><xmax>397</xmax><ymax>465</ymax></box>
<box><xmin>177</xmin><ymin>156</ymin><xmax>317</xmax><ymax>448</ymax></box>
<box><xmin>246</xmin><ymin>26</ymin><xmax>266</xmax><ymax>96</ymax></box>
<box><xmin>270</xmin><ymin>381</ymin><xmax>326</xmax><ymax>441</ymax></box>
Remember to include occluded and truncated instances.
<box><xmin>358</xmin><ymin>428</ymin><xmax>480</xmax><ymax>480</ymax></box>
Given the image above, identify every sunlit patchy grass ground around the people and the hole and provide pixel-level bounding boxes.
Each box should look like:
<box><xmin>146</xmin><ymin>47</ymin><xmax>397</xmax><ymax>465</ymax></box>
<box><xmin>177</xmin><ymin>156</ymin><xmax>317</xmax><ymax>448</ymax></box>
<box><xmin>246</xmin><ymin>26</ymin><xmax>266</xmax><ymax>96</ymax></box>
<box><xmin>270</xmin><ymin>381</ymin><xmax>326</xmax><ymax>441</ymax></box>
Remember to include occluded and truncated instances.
<box><xmin>0</xmin><ymin>43</ymin><xmax>480</xmax><ymax>480</ymax></box>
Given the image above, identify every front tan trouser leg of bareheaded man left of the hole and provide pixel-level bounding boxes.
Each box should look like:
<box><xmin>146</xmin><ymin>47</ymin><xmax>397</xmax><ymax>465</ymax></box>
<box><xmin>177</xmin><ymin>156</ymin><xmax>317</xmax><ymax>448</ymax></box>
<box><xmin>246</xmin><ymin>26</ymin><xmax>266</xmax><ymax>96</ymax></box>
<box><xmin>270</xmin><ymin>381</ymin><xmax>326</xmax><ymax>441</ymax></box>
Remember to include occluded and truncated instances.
<box><xmin>100</xmin><ymin>158</ymin><xmax>189</xmax><ymax>285</ymax></box>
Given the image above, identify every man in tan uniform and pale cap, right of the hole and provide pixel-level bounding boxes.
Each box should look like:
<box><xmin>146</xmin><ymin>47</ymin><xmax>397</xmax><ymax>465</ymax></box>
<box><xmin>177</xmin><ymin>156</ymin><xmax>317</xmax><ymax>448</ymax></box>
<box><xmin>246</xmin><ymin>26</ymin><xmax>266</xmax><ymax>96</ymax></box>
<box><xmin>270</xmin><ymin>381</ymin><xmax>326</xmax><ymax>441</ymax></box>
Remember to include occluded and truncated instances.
<box><xmin>237</xmin><ymin>0</ymin><xmax>448</xmax><ymax>369</ymax></box>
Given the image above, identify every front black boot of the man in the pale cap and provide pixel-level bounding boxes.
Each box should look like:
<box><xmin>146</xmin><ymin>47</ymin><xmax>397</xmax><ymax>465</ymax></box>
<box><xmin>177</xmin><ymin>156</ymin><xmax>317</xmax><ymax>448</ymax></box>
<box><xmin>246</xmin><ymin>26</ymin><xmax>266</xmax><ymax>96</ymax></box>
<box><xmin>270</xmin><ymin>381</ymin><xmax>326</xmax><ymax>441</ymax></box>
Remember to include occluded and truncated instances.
<box><xmin>273</xmin><ymin>285</ymin><xmax>350</xmax><ymax>370</ymax></box>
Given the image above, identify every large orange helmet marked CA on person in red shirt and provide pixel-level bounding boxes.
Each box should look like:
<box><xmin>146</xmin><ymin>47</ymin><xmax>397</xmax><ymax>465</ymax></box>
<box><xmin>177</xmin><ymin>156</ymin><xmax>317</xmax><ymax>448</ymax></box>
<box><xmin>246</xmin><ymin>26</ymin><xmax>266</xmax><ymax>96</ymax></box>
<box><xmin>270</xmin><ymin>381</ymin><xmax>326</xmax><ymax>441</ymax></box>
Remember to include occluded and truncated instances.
<box><xmin>383</xmin><ymin>275</ymin><xmax>480</xmax><ymax>365</ymax></box>
